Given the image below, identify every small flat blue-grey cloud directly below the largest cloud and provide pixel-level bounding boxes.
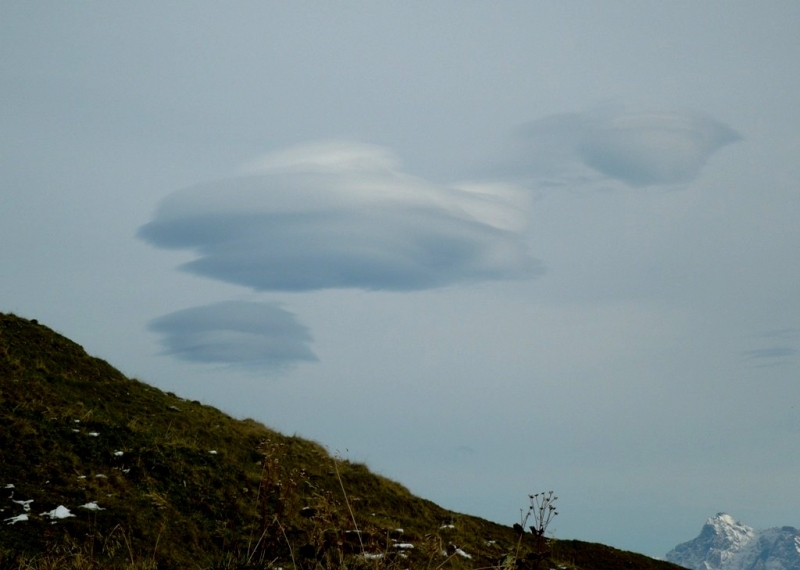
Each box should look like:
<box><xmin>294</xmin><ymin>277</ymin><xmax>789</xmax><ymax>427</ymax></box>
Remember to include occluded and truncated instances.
<box><xmin>148</xmin><ymin>301</ymin><xmax>317</xmax><ymax>369</ymax></box>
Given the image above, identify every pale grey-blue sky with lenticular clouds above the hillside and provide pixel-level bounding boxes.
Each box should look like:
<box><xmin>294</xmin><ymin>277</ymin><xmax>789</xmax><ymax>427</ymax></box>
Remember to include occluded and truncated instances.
<box><xmin>0</xmin><ymin>0</ymin><xmax>800</xmax><ymax>557</ymax></box>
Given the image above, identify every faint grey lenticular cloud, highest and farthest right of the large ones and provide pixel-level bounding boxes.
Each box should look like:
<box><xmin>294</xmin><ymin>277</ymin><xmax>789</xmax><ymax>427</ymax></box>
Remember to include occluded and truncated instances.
<box><xmin>514</xmin><ymin>109</ymin><xmax>741</xmax><ymax>187</ymax></box>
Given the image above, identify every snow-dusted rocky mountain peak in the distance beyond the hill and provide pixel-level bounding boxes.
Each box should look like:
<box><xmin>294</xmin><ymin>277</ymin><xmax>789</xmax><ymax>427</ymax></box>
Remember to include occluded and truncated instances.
<box><xmin>666</xmin><ymin>513</ymin><xmax>800</xmax><ymax>570</ymax></box>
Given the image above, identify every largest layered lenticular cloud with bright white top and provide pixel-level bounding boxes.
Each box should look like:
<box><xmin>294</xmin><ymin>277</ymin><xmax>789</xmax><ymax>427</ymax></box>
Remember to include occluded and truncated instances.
<box><xmin>139</xmin><ymin>142</ymin><xmax>540</xmax><ymax>291</ymax></box>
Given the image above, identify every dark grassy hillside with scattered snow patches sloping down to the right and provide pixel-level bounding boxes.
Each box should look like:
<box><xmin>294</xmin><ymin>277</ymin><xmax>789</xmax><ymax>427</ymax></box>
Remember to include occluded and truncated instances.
<box><xmin>0</xmin><ymin>314</ymin><xmax>677</xmax><ymax>570</ymax></box>
